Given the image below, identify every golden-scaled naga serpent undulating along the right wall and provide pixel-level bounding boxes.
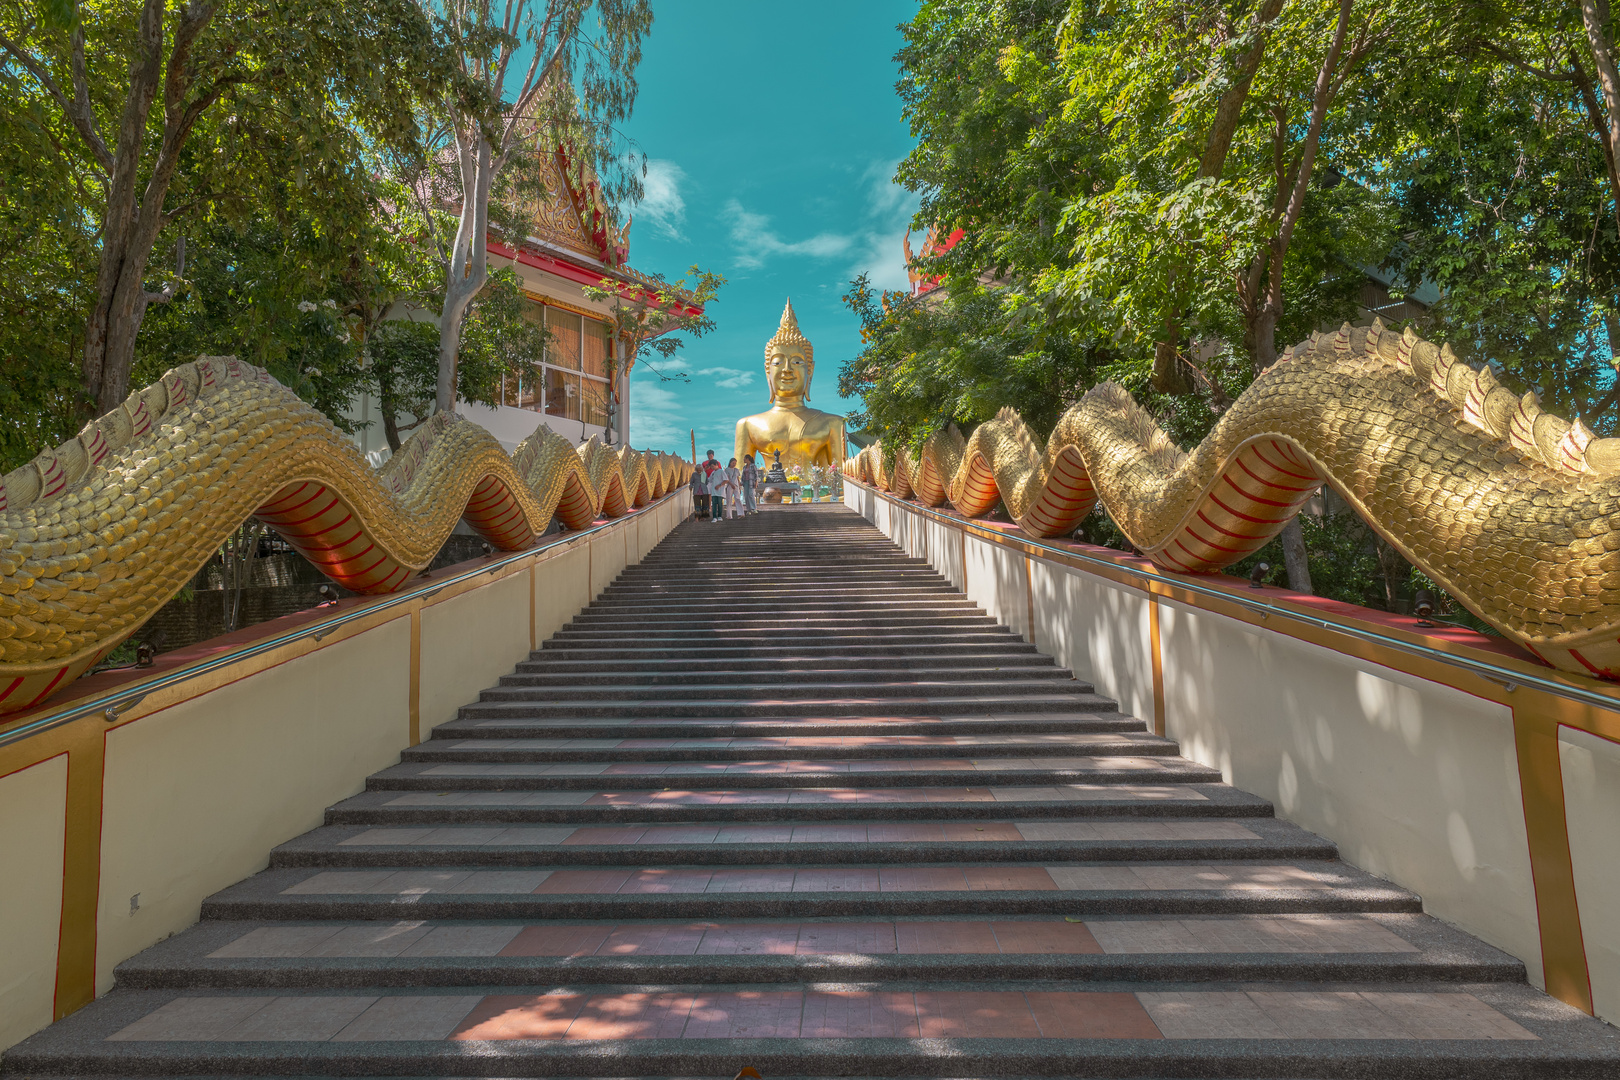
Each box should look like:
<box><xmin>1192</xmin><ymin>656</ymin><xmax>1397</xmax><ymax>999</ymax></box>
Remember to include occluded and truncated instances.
<box><xmin>844</xmin><ymin>321</ymin><xmax>1620</xmax><ymax>678</ymax></box>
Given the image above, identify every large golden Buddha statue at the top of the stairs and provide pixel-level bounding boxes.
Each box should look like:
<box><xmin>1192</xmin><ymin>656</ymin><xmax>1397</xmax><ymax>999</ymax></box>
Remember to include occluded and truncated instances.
<box><xmin>735</xmin><ymin>300</ymin><xmax>844</xmax><ymax>468</ymax></box>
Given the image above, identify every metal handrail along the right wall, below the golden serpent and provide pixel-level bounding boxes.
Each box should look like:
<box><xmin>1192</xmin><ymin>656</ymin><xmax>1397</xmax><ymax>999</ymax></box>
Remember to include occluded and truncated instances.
<box><xmin>844</xmin><ymin>478</ymin><xmax>1620</xmax><ymax>712</ymax></box>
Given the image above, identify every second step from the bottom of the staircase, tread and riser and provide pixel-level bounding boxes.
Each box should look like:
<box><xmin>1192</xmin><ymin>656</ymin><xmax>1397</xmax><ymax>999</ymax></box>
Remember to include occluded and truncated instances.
<box><xmin>115</xmin><ymin>915</ymin><xmax>1524</xmax><ymax>991</ymax></box>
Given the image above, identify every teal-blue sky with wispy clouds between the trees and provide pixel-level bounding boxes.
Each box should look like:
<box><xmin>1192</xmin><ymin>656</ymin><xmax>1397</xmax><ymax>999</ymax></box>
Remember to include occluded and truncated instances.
<box><xmin>612</xmin><ymin>0</ymin><xmax>917</xmax><ymax>458</ymax></box>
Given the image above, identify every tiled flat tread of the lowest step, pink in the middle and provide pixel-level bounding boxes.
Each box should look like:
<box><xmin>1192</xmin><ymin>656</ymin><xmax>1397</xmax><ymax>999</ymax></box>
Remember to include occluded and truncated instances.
<box><xmin>107</xmin><ymin>991</ymin><xmax>1536</xmax><ymax>1043</ymax></box>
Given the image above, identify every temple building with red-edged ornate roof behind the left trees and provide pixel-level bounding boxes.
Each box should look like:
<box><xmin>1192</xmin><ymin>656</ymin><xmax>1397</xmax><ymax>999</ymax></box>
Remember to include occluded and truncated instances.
<box><xmin>353</xmin><ymin>147</ymin><xmax>696</xmax><ymax>453</ymax></box>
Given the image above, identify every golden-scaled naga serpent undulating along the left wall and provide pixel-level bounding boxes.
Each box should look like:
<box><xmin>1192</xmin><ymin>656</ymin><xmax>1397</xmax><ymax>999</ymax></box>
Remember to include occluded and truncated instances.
<box><xmin>0</xmin><ymin>356</ymin><xmax>692</xmax><ymax>714</ymax></box>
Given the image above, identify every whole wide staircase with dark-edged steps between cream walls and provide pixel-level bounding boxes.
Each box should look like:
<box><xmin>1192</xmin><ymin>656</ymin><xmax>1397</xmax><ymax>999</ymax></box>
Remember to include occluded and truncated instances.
<box><xmin>0</xmin><ymin>507</ymin><xmax>1620</xmax><ymax>1080</ymax></box>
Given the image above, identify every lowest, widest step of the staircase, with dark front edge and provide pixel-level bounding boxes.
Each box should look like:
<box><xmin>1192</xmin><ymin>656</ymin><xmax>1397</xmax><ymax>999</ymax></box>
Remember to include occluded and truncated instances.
<box><xmin>6</xmin><ymin>980</ymin><xmax>1617</xmax><ymax>1080</ymax></box>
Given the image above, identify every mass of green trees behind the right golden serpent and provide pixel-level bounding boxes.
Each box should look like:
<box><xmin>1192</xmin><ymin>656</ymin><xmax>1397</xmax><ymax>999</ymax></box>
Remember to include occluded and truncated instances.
<box><xmin>841</xmin><ymin>0</ymin><xmax>1620</xmax><ymax>606</ymax></box>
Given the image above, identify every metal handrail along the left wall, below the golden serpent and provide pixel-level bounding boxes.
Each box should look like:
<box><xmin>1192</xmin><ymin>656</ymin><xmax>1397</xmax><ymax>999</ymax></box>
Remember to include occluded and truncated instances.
<box><xmin>0</xmin><ymin>489</ymin><xmax>685</xmax><ymax>746</ymax></box>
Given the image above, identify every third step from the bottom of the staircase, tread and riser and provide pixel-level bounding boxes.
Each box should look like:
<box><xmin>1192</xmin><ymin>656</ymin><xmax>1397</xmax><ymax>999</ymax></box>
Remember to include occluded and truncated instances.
<box><xmin>203</xmin><ymin>858</ymin><xmax>1422</xmax><ymax>920</ymax></box>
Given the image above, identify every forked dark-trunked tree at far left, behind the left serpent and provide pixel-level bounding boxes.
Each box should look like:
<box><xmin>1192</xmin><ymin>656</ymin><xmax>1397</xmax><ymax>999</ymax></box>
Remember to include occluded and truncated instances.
<box><xmin>0</xmin><ymin>0</ymin><xmax>450</xmax><ymax>415</ymax></box>
